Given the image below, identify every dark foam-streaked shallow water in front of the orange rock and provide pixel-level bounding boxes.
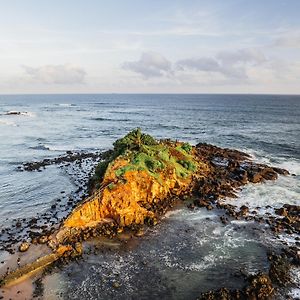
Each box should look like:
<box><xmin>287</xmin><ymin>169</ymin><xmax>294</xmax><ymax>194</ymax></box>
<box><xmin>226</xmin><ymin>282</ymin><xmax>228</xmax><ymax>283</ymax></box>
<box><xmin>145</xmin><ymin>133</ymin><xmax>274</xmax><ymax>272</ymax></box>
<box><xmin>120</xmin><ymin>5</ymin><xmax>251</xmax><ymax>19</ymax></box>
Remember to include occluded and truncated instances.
<box><xmin>42</xmin><ymin>209</ymin><xmax>268</xmax><ymax>299</ymax></box>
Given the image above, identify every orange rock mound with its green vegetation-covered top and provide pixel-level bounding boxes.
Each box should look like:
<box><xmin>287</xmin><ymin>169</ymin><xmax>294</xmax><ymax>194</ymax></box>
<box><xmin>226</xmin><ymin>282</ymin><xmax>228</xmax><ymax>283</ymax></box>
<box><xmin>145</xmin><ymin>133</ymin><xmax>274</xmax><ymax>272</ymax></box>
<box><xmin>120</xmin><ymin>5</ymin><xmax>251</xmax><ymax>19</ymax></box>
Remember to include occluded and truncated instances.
<box><xmin>57</xmin><ymin>130</ymin><xmax>208</xmax><ymax>241</ymax></box>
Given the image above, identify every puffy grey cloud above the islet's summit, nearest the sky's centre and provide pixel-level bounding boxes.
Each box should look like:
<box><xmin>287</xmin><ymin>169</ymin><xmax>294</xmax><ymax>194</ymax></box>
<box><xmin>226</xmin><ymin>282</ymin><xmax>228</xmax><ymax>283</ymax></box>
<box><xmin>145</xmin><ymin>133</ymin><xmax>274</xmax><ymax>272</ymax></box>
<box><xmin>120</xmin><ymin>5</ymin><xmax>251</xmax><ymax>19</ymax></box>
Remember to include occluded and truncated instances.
<box><xmin>122</xmin><ymin>52</ymin><xmax>172</xmax><ymax>79</ymax></box>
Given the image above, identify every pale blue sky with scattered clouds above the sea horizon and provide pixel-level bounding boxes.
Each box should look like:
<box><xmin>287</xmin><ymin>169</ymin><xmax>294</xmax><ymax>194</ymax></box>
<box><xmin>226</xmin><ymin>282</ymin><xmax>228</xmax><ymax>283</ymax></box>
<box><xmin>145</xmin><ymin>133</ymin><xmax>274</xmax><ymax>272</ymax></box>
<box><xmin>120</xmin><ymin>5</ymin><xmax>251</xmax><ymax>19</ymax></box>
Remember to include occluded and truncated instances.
<box><xmin>0</xmin><ymin>0</ymin><xmax>300</xmax><ymax>94</ymax></box>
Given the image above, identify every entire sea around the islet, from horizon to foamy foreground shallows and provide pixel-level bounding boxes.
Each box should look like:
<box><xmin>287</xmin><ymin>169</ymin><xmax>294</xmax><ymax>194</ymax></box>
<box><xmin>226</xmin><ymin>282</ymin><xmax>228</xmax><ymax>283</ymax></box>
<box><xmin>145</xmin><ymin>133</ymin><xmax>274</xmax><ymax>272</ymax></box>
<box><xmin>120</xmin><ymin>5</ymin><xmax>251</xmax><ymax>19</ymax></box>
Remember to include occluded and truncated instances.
<box><xmin>0</xmin><ymin>94</ymin><xmax>300</xmax><ymax>299</ymax></box>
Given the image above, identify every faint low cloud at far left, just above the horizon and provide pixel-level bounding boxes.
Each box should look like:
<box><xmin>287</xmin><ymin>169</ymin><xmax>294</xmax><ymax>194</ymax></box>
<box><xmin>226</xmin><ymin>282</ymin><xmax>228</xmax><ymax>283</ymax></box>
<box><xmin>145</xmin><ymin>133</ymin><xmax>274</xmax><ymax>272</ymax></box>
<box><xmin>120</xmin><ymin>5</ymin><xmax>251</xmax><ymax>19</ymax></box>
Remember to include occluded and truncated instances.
<box><xmin>22</xmin><ymin>64</ymin><xmax>86</xmax><ymax>84</ymax></box>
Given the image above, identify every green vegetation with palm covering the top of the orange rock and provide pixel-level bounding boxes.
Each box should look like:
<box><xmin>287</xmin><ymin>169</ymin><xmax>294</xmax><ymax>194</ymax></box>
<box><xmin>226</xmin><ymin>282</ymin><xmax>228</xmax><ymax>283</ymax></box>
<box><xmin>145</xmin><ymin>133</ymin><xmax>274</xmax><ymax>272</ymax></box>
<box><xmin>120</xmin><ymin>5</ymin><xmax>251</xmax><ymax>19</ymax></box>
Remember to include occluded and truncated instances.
<box><xmin>92</xmin><ymin>128</ymin><xmax>197</xmax><ymax>188</ymax></box>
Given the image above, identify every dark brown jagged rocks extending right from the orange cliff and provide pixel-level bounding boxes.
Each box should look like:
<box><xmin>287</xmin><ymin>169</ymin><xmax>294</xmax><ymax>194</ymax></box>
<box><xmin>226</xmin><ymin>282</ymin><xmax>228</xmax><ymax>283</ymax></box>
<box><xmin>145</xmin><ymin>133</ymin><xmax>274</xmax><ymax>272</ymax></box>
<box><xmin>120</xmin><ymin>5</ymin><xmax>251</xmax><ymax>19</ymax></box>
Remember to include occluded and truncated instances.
<box><xmin>194</xmin><ymin>143</ymin><xmax>289</xmax><ymax>206</ymax></box>
